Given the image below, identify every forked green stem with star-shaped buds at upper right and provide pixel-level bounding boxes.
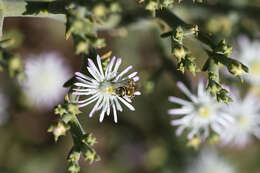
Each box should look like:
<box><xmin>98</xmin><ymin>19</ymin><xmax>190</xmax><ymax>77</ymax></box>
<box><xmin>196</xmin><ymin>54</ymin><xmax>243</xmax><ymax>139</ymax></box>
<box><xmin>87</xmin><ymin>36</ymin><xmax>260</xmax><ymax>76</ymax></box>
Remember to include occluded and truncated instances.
<box><xmin>161</xmin><ymin>10</ymin><xmax>248</xmax><ymax>103</ymax></box>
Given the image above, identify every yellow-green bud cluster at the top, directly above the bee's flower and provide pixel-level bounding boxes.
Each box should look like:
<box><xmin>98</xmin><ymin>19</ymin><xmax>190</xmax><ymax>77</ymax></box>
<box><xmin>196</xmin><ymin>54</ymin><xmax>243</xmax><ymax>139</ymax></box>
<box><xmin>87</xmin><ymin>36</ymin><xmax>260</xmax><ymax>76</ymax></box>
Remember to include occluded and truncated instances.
<box><xmin>65</xmin><ymin>1</ymin><xmax>121</xmax><ymax>54</ymax></box>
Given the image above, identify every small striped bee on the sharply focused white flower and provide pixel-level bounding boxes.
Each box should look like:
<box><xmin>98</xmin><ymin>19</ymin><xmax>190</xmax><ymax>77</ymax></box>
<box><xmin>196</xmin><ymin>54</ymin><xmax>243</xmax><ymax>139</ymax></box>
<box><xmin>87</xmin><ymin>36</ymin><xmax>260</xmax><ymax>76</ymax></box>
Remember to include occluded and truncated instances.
<box><xmin>116</xmin><ymin>79</ymin><xmax>137</xmax><ymax>99</ymax></box>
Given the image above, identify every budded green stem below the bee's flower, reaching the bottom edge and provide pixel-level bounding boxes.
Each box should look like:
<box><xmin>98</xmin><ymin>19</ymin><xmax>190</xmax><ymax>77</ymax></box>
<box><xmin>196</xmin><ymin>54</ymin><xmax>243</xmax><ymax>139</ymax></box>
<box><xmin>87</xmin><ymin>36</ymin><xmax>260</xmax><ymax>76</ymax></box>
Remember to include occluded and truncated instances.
<box><xmin>48</xmin><ymin>95</ymin><xmax>99</xmax><ymax>173</ymax></box>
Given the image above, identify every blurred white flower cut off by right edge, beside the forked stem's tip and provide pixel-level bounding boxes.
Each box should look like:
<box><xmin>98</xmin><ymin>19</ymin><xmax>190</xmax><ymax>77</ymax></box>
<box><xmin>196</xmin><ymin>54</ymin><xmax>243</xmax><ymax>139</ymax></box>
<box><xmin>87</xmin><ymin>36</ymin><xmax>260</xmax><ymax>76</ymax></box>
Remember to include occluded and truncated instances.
<box><xmin>233</xmin><ymin>36</ymin><xmax>260</xmax><ymax>86</ymax></box>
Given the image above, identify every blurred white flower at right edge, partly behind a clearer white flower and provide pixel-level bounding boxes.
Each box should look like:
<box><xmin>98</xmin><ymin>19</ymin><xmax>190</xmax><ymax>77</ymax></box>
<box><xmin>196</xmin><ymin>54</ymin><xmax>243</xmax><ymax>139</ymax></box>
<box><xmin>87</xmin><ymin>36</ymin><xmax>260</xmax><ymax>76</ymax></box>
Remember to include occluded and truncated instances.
<box><xmin>221</xmin><ymin>94</ymin><xmax>260</xmax><ymax>148</ymax></box>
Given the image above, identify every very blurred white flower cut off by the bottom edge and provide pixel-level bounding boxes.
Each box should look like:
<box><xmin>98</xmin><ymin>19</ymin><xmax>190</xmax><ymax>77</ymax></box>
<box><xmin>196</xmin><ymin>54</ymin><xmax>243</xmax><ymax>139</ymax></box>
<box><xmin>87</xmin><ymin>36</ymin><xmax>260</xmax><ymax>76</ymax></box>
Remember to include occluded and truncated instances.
<box><xmin>186</xmin><ymin>148</ymin><xmax>235</xmax><ymax>173</ymax></box>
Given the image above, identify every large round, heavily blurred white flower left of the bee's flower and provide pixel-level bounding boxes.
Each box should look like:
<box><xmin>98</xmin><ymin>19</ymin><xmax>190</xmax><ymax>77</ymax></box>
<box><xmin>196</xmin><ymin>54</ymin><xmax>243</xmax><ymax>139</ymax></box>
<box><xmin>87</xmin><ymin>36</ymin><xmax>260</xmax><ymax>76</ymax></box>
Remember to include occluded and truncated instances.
<box><xmin>22</xmin><ymin>52</ymin><xmax>71</xmax><ymax>108</ymax></box>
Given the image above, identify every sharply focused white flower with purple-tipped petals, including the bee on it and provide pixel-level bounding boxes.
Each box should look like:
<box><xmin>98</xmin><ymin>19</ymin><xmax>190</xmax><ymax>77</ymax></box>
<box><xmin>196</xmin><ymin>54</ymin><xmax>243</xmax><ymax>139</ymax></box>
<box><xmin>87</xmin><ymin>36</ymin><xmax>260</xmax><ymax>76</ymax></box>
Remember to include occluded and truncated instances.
<box><xmin>73</xmin><ymin>56</ymin><xmax>141</xmax><ymax>123</ymax></box>
